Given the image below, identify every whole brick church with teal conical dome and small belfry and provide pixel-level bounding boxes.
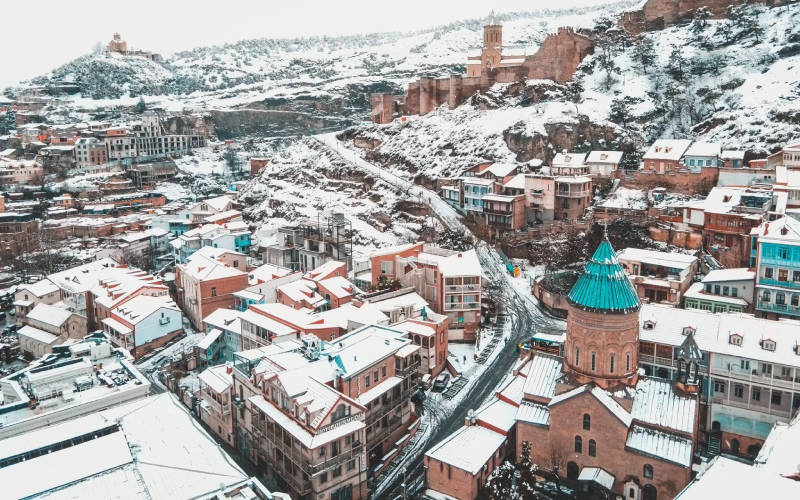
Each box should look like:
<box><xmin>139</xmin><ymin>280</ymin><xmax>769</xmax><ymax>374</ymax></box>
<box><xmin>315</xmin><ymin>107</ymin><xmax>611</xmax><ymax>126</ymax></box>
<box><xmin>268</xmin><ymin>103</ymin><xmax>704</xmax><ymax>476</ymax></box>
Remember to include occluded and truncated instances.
<box><xmin>516</xmin><ymin>239</ymin><xmax>701</xmax><ymax>500</ymax></box>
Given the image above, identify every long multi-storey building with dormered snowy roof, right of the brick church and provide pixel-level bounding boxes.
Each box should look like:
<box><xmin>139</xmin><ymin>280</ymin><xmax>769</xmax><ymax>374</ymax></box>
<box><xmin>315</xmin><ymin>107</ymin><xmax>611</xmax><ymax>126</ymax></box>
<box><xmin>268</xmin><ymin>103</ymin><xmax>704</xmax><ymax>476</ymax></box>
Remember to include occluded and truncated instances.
<box><xmin>639</xmin><ymin>304</ymin><xmax>800</xmax><ymax>459</ymax></box>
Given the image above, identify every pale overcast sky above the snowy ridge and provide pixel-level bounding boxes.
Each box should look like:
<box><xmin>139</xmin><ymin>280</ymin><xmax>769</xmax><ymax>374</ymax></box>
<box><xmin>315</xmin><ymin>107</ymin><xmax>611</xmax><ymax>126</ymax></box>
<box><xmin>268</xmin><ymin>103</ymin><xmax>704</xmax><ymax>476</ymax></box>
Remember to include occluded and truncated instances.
<box><xmin>0</xmin><ymin>0</ymin><xmax>611</xmax><ymax>89</ymax></box>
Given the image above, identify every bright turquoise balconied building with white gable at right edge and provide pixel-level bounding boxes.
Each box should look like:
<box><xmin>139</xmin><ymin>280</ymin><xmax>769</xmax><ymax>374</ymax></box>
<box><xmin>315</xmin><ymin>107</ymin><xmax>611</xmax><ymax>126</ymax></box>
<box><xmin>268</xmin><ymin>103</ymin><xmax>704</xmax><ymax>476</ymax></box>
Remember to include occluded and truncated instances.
<box><xmin>751</xmin><ymin>217</ymin><xmax>800</xmax><ymax>319</ymax></box>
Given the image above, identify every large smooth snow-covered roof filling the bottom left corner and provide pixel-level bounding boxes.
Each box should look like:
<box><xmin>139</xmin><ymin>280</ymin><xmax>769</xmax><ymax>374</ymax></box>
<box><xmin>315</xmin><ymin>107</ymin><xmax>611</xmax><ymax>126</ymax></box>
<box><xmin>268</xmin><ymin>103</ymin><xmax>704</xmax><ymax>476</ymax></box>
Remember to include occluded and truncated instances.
<box><xmin>0</xmin><ymin>393</ymin><xmax>253</xmax><ymax>499</ymax></box>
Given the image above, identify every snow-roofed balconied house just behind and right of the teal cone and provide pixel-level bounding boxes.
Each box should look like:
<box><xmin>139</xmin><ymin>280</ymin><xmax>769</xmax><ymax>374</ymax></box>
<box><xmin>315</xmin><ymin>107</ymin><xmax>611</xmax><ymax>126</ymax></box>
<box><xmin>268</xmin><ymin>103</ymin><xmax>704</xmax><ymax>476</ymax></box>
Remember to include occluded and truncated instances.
<box><xmin>617</xmin><ymin>248</ymin><xmax>700</xmax><ymax>307</ymax></box>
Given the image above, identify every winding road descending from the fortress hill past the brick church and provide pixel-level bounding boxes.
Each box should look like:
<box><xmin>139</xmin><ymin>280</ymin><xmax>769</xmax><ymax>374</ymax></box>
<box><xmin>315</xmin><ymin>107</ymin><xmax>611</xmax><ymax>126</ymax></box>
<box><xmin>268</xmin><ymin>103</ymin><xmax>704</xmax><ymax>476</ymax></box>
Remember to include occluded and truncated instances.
<box><xmin>314</xmin><ymin>133</ymin><xmax>566</xmax><ymax>500</ymax></box>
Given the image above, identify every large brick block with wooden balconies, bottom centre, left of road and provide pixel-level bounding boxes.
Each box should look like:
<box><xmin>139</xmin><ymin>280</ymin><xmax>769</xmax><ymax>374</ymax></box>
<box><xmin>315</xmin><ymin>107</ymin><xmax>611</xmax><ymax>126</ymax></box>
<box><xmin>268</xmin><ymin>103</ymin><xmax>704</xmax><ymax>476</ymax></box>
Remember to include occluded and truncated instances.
<box><xmin>233</xmin><ymin>326</ymin><xmax>419</xmax><ymax>500</ymax></box>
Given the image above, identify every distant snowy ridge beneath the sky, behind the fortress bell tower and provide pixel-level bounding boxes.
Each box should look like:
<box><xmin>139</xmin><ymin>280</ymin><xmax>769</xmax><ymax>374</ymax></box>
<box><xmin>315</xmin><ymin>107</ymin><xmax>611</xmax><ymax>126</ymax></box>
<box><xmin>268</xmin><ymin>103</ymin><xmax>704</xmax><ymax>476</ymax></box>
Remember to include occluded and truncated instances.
<box><xmin>25</xmin><ymin>1</ymin><xmax>633</xmax><ymax>116</ymax></box>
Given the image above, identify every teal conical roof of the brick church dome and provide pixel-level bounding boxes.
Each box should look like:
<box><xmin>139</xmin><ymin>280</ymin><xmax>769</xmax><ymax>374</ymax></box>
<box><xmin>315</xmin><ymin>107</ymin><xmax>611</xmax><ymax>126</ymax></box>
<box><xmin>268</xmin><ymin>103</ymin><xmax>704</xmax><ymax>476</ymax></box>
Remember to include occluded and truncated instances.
<box><xmin>568</xmin><ymin>239</ymin><xmax>642</xmax><ymax>314</ymax></box>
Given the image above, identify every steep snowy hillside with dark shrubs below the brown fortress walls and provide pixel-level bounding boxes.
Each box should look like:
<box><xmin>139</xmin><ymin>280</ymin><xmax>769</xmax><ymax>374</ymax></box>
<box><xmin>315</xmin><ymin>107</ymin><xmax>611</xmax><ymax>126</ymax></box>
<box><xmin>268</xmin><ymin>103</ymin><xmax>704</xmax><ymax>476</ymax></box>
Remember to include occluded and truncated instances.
<box><xmin>345</xmin><ymin>4</ymin><xmax>800</xmax><ymax>181</ymax></box>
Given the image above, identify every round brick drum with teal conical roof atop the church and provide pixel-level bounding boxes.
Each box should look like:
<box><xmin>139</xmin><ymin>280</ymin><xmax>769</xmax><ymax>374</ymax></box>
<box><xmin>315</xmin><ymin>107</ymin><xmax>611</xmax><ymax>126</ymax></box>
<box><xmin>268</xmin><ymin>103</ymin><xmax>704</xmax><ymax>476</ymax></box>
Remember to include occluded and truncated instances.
<box><xmin>564</xmin><ymin>237</ymin><xmax>642</xmax><ymax>389</ymax></box>
